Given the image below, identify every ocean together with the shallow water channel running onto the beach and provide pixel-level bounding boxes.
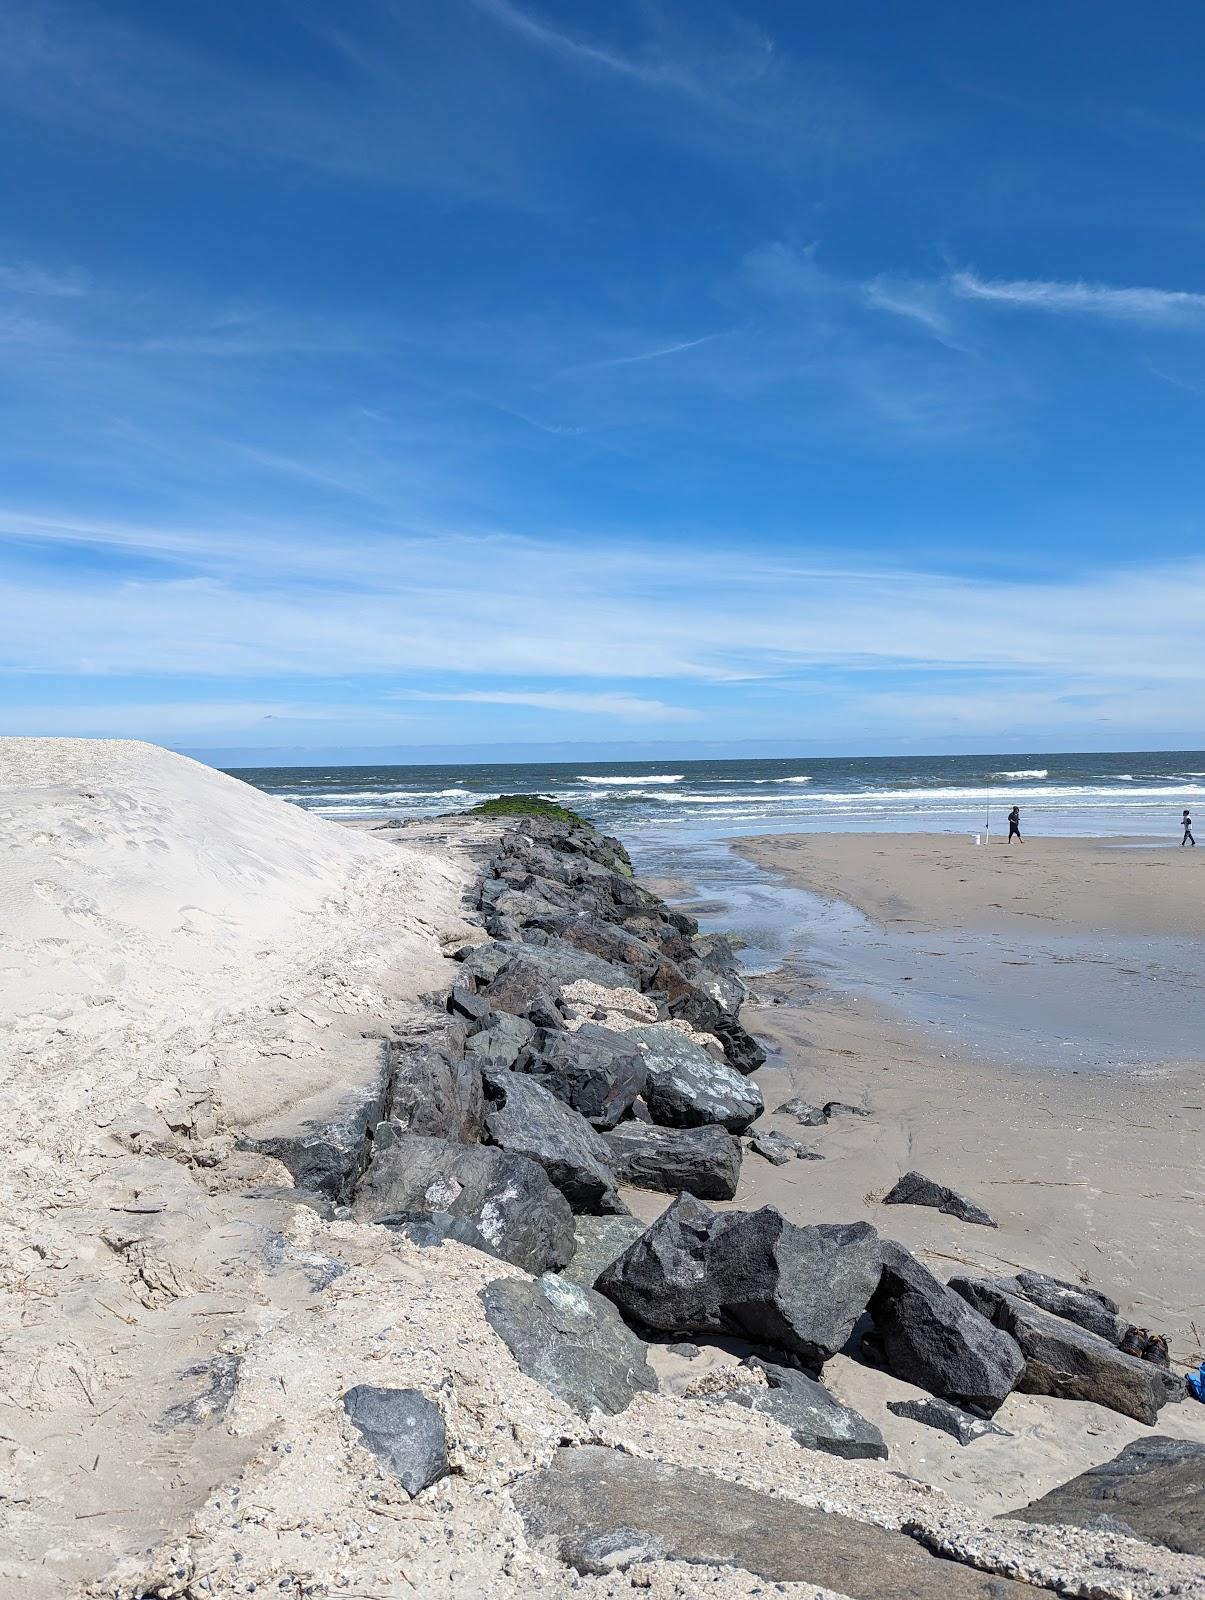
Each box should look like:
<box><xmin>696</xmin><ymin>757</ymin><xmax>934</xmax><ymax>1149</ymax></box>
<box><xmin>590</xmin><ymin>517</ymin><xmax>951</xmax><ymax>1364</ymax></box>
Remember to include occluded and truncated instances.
<box><xmin>235</xmin><ymin>750</ymin><xmax>1205</xmax><ymax>1070</ymax></box>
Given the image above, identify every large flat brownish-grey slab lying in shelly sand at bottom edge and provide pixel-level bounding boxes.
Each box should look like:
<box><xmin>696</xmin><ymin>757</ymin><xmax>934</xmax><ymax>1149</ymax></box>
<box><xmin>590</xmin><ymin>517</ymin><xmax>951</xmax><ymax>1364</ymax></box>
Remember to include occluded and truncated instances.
<box><xmin>510</xmin><ymin>1445</ymin><xmax>1048</xmax><ymax>1600</ymax></box>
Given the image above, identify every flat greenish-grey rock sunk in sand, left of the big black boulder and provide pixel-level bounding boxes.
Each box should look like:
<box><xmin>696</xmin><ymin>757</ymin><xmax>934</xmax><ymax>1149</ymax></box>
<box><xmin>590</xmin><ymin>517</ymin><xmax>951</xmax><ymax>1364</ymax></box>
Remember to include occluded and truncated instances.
<box><xmin>482</xmin><ymin>1274</ymin><xmax>656</xmax><ymax>1416</ymax></box>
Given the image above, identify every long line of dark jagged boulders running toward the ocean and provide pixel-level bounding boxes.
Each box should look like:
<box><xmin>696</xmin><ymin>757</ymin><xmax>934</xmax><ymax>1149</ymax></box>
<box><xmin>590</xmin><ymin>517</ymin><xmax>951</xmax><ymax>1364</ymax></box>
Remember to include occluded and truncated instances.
<box><xmin>316</xmin><ymin>818</ymin><xmax>1199</xmax><ymax>1600</ymax></box>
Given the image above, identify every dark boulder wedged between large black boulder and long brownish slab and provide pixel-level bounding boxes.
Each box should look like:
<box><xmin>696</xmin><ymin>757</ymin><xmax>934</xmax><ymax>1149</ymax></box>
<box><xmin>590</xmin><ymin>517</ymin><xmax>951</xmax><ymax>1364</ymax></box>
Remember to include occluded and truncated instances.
<box><xmin>871</xmin><ymin>1240</ymin><xmax>1026</xmax><ymax>1416</ymax></box>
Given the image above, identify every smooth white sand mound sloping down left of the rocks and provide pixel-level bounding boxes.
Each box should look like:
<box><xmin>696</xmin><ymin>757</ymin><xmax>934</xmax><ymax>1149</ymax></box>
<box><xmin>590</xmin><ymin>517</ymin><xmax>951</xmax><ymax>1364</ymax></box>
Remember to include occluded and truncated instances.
<box><xmin>0</xmin><ymin>739</ymin><xmax>467</xmax><ymax>1594</ymax></box>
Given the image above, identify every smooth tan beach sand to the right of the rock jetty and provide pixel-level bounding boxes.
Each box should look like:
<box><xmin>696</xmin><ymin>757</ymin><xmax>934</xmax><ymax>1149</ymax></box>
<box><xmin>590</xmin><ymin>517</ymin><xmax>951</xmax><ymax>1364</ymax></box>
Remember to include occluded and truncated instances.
<box><xmin>713</xmin><ymin>835</ymin><xmax>1205</xmax><ymax>1504</ymax></box>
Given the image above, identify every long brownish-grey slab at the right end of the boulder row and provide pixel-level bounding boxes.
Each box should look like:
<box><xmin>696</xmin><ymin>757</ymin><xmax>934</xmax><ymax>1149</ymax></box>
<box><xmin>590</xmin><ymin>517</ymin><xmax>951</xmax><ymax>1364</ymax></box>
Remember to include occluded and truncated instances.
<box><xmin>949</xmin><ymin>1275</ymin><xmax>1184</xmax><ymax>1424</ymax></box>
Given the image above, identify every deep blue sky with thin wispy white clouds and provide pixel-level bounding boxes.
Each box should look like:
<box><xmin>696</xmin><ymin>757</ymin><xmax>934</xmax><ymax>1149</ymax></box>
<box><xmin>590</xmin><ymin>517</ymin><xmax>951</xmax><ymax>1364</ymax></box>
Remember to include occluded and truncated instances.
<box><xmin>0</xmin><ymin>0</ymin><xmax>1205</xmax><ymax>762</ymax></box>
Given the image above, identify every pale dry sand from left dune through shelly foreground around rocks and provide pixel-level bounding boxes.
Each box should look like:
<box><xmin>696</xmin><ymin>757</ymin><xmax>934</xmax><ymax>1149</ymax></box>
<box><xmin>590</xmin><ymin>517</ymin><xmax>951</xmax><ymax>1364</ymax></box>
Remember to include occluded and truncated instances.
<box><xmin>0</xmin><ymin>764</ymin><xmax>1205</xmax><ymax>1600</ymax></box>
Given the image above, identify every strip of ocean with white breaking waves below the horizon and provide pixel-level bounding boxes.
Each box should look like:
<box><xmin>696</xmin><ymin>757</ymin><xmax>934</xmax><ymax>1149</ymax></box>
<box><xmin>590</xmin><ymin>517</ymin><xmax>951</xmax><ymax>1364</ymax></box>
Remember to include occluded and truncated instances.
<box><xmin>237</xmin><ymin>750</ymin><xmax>1205</xmax><ymax>848</ymax></box>
